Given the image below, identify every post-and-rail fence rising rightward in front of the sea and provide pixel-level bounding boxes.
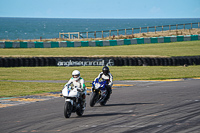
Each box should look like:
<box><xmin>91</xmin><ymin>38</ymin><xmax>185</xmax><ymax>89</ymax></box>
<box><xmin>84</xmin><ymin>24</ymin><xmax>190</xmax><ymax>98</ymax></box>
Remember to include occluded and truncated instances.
<box><xmin>59</xmin><ymin>22</ymin><xmax>200</xmax><ymax>39</ymax></box>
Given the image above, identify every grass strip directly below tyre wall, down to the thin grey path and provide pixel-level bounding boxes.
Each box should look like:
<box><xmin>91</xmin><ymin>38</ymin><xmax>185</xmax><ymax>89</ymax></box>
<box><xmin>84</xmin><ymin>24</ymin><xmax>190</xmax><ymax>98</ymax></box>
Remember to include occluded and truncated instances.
<box><xmin>0</xmin><ymin>65</ymin><xmax>200</xmax><ymax>81</ymax></box>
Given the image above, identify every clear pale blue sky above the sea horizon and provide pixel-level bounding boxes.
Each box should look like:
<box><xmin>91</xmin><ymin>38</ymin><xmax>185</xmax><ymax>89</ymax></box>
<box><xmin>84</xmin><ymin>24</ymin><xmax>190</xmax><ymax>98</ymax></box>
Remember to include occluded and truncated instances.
<box><xmin>0</xmin><ymin>0</ymin><xmax>200</xmax><ymax>18</ymax></box>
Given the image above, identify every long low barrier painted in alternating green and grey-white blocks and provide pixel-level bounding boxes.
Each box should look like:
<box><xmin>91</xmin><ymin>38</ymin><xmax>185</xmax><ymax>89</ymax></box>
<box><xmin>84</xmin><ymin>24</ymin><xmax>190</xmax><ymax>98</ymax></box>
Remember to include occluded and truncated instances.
<box><xmin>0</xmin><ymin>34</ymin><xmax>200</xmax><ymax>48</ymax></box>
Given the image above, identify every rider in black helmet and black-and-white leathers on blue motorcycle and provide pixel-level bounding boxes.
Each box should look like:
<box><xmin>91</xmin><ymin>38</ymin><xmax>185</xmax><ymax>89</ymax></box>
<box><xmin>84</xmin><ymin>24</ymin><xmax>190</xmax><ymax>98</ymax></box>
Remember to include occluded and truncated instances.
<box><xmin>94</xmin><ymin>66</ymin><xmax>113</xmax><ymax>100</ymax></box>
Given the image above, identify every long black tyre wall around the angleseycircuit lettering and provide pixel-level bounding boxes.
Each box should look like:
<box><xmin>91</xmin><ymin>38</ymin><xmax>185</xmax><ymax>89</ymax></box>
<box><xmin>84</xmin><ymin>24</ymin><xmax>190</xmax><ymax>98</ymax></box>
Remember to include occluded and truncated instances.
<box><xmin>0</xmin><ymin>56</ymin><xmax>200</xmax><ymax>67</ymax></box>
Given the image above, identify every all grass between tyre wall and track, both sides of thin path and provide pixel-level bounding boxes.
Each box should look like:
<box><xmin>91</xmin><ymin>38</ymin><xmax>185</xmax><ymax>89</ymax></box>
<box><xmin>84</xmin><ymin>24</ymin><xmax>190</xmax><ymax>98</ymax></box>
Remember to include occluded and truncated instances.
<box><xmin>0</xmin><ymin>66</ymin><xmax>200</xmax><ymax>97</ymax></box>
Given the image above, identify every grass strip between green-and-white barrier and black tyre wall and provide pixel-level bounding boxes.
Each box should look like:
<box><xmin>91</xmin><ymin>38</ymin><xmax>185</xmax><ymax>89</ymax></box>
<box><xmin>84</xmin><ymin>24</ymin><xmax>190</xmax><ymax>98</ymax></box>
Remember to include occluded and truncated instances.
<box><xmin>0</xmin><ymin>41</ymin><xmax>200</xmax><ymax>57</ymax></box>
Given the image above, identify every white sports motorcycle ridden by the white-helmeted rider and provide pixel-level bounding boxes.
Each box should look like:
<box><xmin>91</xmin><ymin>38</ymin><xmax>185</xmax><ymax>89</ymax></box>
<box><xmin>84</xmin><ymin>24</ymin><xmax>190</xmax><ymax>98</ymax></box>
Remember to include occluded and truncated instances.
<box><xmin>62</xmin><ymin>86</ymin><xmax>86</xmax><ymax>118</ymax></box>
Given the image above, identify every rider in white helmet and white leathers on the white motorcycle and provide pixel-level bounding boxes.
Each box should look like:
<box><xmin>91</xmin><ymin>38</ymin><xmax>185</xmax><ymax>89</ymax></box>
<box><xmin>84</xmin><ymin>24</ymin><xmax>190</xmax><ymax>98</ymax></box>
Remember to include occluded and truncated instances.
<box><xmin>65</xmin><ymin>70</ymin><xmax>87</xmax><ymax>109</ymax></box>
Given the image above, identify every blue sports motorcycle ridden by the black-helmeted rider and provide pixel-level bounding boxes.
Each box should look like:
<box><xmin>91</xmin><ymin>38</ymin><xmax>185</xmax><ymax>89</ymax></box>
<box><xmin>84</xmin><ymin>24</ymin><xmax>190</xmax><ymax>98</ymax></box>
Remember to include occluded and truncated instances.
<box><xmin>90</xmin><ymin>79</ymin><xmax>108</xmax><ymax>107</ymax></box>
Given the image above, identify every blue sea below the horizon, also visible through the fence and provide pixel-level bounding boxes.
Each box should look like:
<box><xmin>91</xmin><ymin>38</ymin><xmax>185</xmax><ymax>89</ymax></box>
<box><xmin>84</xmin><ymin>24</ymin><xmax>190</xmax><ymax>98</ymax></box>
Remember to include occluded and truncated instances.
<box><xmin>0</xmin><ymin>17</ymin><xmax>200</xmax><ymax>40</ymax></box>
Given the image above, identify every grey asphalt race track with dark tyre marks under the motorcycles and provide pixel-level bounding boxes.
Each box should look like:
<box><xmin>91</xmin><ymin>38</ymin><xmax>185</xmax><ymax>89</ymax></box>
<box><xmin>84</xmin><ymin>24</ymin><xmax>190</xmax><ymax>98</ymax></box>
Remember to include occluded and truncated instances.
<box><xmin>0</xmin><ymin>79</ymin><xmax>200</xmax><ymax>133</ymax></box>
